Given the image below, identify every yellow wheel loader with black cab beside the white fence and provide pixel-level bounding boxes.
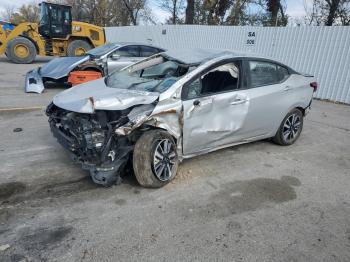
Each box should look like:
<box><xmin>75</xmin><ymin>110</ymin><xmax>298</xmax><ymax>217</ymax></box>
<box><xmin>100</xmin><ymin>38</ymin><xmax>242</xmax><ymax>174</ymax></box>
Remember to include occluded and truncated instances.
<box><xmin>0</xmin><ymin>2</ymin><xmax>106</xmax><ymax>64</ymax></box>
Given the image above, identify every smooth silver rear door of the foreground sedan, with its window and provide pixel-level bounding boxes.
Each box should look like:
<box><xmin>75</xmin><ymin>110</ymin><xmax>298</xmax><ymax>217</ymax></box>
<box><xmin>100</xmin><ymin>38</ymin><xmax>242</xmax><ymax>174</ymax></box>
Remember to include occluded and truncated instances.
<box><xmin>232</xmin><ymin>59</ymin><xmax>295</xmax><ymax>140</ymax></box>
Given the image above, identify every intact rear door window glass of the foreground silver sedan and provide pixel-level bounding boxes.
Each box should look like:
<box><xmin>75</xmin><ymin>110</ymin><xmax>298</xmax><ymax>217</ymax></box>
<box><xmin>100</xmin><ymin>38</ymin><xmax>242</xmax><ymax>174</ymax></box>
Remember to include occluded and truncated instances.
<box><xmin>249</xmin><ymin>61</ymin><xmax>289</xmax><ymax>87</ymax></box>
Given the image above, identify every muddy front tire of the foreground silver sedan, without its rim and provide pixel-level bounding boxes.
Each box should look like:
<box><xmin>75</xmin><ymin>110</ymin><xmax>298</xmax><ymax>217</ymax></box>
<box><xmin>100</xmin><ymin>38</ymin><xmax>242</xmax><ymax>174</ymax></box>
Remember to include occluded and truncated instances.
<box><xmin>133</xmin><ymin>130</ymin><xmax>178</xmax><ymax>188</ymax></box>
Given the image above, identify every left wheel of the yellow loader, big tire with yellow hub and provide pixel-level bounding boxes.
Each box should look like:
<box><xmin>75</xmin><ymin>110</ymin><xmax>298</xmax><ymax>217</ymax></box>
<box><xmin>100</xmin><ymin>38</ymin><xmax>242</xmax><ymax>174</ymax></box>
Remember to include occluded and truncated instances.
<box><xmin>6</xmin><ymin>37</ymin><xmax>36</xmax><ymax>64</ymax></box>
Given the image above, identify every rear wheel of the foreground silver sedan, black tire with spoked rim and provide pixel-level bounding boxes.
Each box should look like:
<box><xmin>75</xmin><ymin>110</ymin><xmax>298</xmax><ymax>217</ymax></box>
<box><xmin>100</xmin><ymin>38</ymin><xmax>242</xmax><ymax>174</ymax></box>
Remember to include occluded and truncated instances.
<box><xmin>272</xmin><ymin>109</ymin><xmax>304</xmax><ymax>146</ymax></box>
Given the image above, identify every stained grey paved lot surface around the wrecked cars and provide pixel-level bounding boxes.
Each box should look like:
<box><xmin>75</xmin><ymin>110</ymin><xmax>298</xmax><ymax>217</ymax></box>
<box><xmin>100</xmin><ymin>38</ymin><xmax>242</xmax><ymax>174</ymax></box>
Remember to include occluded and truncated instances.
<box><xmin>0</xmin><ymin>57</ymin><xmax>350</xmax><ymax>262</ymax></box>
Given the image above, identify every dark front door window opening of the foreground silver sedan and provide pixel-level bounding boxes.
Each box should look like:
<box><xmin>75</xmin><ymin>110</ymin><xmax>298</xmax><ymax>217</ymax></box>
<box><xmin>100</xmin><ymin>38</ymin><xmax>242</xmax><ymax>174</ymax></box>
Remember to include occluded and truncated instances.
<box><xmin>201</xmin><ymin>62</ymin><xmax>239</xmax><ymax>95</ymax></box>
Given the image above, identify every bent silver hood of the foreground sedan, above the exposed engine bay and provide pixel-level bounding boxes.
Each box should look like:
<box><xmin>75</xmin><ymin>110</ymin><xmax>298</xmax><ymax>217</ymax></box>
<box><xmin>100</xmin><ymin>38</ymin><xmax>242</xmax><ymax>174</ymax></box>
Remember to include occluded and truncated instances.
<box><xmin>53</xmin><ymin>78</ymin><xmax>159</xmax><ymax>113</ymax></box>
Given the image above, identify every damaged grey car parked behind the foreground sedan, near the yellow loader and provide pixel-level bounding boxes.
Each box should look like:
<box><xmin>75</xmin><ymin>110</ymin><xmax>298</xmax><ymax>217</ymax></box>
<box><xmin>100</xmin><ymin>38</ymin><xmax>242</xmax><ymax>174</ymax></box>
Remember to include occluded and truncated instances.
<box><xmin>24</xmin><ymin>43</ymin><xmax>164</xmax><ymax>94</ymax></box>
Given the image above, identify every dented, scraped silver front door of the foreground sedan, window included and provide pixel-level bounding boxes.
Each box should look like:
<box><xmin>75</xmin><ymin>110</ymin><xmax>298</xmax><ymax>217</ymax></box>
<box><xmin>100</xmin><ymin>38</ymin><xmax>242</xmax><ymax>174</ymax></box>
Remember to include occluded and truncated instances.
<box><xmin>182</xmin><ymin>60</ymin><xmax>249</xmax><ymax>155</ymax></box>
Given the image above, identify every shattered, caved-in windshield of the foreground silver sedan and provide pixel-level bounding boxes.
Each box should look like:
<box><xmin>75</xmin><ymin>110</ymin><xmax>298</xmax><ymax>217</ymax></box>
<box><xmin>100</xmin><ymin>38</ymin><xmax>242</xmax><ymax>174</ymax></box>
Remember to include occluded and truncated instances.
<box><xmin>106</xmin><ymin>56</ymin><xmax>189</xmax><ymax>93</ymax></box>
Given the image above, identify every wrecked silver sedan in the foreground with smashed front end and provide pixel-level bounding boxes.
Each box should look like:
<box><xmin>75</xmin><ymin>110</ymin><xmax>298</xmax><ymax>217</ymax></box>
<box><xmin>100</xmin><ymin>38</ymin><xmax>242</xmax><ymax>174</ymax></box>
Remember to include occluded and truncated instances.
<box><xmin>46</xmin><ymin>49</ymin><xmax>317</xmax><ymax>187</ymax></box>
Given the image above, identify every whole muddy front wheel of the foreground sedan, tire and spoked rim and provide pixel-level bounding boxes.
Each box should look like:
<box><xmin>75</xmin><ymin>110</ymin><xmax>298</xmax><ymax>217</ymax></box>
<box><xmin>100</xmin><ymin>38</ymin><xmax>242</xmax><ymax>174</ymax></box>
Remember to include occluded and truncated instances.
<box><xmin>133</xmin><ymin>130</ymin><xmax>178</xmax><ymax>188</ymax></box>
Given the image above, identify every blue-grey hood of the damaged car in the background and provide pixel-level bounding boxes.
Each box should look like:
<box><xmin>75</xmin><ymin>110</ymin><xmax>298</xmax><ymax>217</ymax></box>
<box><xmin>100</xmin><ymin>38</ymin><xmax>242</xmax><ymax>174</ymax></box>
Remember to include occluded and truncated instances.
<box><xmin>40</xmin><ymin>55</ymin><xmax>90</xmax><ymax>79</ymax></box>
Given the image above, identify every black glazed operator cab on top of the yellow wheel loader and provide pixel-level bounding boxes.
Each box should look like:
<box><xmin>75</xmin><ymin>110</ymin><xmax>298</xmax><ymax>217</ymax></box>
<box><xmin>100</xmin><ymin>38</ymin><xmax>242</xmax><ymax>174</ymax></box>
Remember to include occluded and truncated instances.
<box><xmin>39</xmin><ymin>2</ymin><xmax>72</xmax><ymax>38</ymax></box>
